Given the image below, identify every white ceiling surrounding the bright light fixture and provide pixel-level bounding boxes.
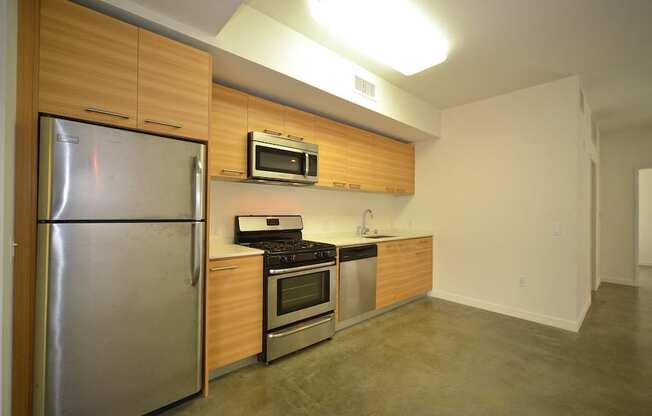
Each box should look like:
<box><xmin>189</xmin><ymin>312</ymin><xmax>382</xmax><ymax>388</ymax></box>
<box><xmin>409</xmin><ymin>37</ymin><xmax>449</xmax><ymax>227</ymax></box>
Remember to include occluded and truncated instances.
<box><xmin>247</xmin><ymin>0</ymin><xmax>652</xmax><ymax>131</ymax></box>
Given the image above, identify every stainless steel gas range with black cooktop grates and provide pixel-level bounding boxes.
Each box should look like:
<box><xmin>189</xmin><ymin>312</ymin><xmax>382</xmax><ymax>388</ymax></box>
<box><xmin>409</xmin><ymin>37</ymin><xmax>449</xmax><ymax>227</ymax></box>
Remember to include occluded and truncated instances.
<box><xmin>235</xmin><ymin>215</ymin><xmax>337</xmax><ymax>362</ymax></box>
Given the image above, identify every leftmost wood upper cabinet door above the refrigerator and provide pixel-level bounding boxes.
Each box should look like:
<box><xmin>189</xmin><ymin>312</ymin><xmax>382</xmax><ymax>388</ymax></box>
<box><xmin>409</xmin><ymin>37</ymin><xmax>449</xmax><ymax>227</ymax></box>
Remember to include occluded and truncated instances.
<box><xmin>39</xmin><ymin>0</ymin><xmax>138</xmax><ymax>128</ymax></box>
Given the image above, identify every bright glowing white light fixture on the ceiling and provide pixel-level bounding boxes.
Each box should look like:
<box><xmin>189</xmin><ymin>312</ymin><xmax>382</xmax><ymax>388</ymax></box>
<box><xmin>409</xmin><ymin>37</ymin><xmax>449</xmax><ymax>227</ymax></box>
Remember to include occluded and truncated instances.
<box><xmin>310</xmin><ymin>0</ymin><xmax>448</xmax><ymax>76</ymax></box>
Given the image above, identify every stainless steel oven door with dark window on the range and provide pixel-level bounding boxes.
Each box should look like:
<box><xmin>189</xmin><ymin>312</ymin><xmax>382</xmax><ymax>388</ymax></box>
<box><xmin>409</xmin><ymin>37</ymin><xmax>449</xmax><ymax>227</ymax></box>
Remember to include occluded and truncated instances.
<box><xmin>267</xmin><ymin>262</ymin><xmax>336</xmax><ymax>329</ymax></box>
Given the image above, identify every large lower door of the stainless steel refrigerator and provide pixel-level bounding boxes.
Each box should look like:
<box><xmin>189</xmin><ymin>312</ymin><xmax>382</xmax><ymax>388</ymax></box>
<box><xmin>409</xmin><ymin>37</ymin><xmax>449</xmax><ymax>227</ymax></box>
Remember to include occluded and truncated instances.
<box><xmin>35</xmin><ymin>222</ymin><xmax>204</xmax><ymax>416</ymax></box>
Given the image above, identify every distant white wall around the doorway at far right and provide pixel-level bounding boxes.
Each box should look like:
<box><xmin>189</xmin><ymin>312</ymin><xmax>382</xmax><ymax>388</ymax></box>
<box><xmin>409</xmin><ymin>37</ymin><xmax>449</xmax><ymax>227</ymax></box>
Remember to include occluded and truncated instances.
<box><xmin>600</xmin><ymin>126</ymin><xmax>652</xmax><ymax>285</ymax></box>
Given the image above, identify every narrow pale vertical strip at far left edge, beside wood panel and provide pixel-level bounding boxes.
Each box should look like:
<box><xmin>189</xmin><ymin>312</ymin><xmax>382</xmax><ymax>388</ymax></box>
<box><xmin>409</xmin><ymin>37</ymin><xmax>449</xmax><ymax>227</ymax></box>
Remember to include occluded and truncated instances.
<box><xmin>0</xmin><ymin>0</ymin><xmax>17</xmax><ymax>416</ymax></box>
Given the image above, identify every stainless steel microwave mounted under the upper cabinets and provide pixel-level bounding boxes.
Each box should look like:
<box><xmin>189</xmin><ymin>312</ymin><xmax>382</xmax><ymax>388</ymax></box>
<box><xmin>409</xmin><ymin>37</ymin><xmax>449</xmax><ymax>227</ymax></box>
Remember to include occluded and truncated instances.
<box><xmin>249</xmin><ymin>140</ymin><xmax>317</xmax><ymax>183</ymax></box>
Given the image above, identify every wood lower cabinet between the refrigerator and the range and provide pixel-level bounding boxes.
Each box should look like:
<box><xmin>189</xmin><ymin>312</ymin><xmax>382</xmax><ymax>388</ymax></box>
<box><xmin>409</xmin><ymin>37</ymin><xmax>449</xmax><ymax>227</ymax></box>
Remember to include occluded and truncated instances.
<box><xmin>206</xmin><ymin>256</ymin><xmax>263</xmax><ymax>370</ymax></box>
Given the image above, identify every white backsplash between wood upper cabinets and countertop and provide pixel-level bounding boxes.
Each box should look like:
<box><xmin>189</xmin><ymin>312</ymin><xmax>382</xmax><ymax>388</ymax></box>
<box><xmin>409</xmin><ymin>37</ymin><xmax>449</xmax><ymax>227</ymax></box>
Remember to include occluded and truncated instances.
<box><xmin>210</xmin><ymin>180</ymin><xmax>409</xmax><ymax>242</ymax></box>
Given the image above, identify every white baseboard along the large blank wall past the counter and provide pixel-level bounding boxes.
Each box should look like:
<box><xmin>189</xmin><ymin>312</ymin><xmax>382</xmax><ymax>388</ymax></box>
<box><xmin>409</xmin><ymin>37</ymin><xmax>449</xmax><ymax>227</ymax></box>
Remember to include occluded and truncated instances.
<box><xmin>432</xmin><ymin>290</ymin><xmax>581</xmax><ymax>332</ymax></box>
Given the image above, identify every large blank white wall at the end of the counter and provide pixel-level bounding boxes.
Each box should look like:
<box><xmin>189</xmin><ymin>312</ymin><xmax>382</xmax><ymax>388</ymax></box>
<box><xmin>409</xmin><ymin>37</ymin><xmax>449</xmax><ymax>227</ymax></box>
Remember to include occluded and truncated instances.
<box><xmin>397</xmin><ymin>77</ymin><xmax>582</xmax><ymax>330</ymax></box>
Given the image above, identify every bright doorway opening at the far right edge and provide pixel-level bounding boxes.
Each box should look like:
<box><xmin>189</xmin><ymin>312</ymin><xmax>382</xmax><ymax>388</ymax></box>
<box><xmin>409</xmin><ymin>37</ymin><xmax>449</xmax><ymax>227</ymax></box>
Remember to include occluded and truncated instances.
<box><xmin>634</xmin><ymin>169</ymin><xmax>652</xmax><ymax>289</ymax></box>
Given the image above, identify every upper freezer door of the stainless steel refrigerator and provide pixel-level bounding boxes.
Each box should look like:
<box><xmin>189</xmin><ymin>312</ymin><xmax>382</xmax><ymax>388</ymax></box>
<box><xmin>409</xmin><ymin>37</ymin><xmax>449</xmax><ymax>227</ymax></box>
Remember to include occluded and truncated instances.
<box><xmin>39</xmin><ymin>117</ymin><xmax>206</xmax><ymax>221</ymax></box>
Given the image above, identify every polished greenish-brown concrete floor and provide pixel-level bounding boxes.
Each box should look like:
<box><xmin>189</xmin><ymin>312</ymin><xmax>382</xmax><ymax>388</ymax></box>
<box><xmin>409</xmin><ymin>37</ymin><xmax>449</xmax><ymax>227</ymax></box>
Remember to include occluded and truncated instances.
<box><xmin>166</xmin><ymin>284</ymin><xmax>652</xmax><ymax>416</ymax></box>
